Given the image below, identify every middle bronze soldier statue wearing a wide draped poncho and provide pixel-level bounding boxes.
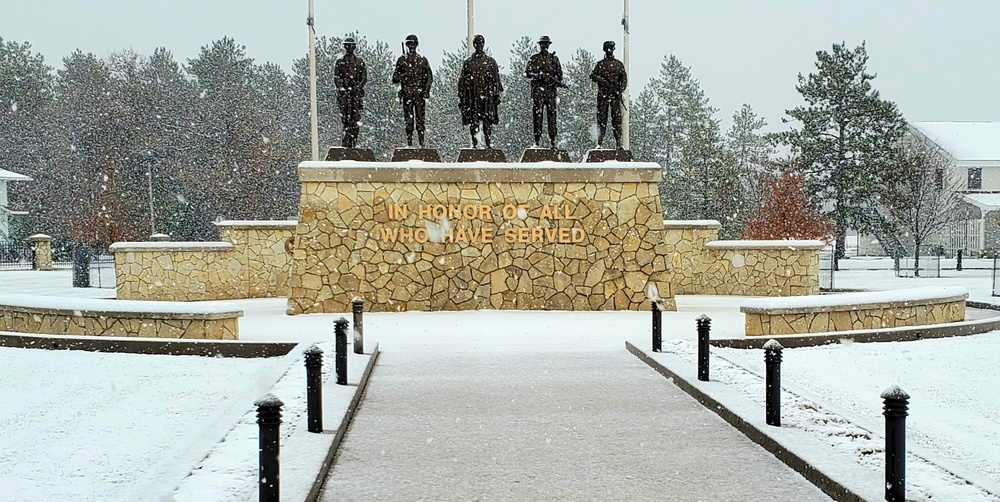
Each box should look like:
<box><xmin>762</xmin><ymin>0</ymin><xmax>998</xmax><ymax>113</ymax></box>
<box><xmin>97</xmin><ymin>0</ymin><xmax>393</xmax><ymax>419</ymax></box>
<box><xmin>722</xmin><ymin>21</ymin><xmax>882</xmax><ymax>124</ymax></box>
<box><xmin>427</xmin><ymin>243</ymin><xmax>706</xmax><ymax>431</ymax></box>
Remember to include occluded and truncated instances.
<box><xmin>458</xmin><ymin>35</ymin><xmax>503</xmax><ymax>148</ymax></box>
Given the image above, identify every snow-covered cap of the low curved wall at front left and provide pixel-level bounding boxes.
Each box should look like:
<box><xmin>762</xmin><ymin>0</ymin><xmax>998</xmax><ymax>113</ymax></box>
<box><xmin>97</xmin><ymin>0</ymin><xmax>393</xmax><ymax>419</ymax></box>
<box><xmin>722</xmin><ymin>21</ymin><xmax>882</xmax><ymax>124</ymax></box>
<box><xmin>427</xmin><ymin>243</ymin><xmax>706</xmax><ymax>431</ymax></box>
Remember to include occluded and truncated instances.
<box><xmin>0</xmin><ymin>293</ymin><xmax>243</xmax><ymax>319</ymax></box>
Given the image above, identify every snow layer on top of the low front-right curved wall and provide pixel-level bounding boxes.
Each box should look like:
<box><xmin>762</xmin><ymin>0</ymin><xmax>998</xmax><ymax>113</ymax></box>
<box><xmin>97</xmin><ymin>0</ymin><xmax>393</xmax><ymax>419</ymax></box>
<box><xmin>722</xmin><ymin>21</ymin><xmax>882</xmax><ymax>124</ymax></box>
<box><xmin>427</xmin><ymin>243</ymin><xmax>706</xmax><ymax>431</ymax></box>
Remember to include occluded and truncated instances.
<box><xmin>740</xmin><ymin>286</ymin><xmax>969</xmax><ymax>312</ymax></box>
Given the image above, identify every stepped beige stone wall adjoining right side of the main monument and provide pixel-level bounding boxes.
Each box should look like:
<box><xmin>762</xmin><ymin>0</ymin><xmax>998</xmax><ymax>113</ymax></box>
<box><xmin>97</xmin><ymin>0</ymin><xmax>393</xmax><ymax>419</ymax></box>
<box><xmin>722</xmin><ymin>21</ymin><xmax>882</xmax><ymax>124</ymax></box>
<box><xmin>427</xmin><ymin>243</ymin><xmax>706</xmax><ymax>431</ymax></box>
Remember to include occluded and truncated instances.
<box><xmin>663</xmin><ymin>220</ymin><xmax>824</xmax><ymax>296</ymax></box>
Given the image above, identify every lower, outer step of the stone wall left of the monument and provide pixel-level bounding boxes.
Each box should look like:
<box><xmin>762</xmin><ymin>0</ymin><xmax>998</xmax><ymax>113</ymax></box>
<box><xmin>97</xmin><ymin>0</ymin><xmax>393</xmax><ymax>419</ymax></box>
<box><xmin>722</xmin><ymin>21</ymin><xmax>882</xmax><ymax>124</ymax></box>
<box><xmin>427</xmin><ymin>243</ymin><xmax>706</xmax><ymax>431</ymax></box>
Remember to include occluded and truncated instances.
<box><xmin>111</xmin><ymin>242</ymin><xmax>247</xmax><ymax>301</ymax></box>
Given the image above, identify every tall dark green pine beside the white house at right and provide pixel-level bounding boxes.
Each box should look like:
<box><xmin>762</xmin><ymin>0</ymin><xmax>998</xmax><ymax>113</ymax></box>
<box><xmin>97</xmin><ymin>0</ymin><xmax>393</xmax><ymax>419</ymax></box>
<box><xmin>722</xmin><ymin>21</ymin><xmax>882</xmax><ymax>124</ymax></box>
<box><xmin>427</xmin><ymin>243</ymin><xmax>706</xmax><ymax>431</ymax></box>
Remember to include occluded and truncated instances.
<box><xmin>778</xmin><ymin>43</ymin><xmax>904</xmax><ymax>266</ymax></box>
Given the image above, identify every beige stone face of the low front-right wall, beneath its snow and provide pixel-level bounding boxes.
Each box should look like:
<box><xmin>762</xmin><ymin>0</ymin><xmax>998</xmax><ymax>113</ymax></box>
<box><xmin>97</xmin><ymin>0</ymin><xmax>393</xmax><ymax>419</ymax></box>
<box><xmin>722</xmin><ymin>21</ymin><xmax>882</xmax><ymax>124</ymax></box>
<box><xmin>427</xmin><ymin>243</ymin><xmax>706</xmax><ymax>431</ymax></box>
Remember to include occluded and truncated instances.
<box><xmin>740</xmin><ymin>298</ymin><xmax>965</xmax><ymax>336</ymax></box>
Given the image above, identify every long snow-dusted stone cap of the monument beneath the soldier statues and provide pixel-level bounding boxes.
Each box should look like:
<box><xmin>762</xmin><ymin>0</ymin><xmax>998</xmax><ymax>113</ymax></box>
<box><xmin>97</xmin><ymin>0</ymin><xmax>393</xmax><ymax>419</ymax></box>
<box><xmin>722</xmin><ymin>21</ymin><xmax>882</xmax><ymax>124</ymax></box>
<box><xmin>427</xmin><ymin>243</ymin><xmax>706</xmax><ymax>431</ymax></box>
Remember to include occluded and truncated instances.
<box><xmin>299</xmin><ymin>161</ymin><xmax>663</xmax><ymax>183</ymax></box>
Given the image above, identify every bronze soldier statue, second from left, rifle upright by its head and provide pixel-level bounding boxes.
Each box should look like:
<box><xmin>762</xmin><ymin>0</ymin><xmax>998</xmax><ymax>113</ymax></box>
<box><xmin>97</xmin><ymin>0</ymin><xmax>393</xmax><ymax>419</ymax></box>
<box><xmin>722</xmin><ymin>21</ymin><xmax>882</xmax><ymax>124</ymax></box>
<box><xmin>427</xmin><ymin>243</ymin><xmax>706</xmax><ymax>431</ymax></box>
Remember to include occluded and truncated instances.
<box><xmin>392</xmin><ymin>35</ymin><xmax>434</xmax><ymax>148</ymax></box>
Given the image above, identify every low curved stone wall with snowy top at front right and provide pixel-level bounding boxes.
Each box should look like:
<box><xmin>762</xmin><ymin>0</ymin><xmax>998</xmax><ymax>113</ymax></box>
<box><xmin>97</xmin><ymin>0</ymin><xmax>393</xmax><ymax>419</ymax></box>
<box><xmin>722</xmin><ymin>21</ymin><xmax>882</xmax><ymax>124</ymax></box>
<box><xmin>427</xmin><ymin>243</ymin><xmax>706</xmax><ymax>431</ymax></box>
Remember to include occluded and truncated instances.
<box><xmin>740</xmin><ymin>287</ymin><xmax>969</xmax><ymax>336</ymax></box>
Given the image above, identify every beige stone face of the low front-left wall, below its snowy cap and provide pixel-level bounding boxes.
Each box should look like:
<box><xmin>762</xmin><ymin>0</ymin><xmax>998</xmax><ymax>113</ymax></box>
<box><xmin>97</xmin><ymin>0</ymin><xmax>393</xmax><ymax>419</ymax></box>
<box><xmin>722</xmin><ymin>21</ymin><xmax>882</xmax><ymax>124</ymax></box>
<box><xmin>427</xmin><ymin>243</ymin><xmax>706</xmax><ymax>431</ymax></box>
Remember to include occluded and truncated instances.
<box><xmin>0</xmin><ymin>300</ymin><xmax>243</xmax><ymax>340</ymax></box>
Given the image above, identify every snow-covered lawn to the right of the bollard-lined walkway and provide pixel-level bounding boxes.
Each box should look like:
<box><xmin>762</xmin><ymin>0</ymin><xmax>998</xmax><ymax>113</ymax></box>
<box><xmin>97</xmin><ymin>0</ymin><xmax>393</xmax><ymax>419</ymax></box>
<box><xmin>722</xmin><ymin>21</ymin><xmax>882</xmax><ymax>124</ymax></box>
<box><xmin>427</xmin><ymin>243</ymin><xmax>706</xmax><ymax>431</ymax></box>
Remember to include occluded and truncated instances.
<box><xmin>713</xmin><ymin>332</ymin><xmax>1000</xmax><ymax>486</ymax></box>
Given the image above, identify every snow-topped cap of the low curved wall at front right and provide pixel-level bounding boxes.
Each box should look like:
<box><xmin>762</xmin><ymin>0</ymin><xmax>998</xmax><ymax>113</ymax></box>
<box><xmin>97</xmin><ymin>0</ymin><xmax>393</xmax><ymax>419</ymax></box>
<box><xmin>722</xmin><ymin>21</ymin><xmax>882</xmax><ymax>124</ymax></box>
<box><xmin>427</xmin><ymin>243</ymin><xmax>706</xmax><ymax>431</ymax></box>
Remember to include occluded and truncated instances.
<box><xmin>740</xmin><ymin>286</ymin><xmax>969</xmax><ymax>314</ymax></box>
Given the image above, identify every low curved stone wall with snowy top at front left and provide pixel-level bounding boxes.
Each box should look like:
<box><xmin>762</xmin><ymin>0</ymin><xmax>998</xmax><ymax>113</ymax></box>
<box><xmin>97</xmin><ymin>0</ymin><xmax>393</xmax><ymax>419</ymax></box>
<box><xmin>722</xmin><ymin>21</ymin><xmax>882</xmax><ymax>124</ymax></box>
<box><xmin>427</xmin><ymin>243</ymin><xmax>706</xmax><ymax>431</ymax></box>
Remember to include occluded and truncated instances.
<box><xmin>0</xmin><ymin>295</ymin><xmax>243</xmax><ymax>340</ymax></box>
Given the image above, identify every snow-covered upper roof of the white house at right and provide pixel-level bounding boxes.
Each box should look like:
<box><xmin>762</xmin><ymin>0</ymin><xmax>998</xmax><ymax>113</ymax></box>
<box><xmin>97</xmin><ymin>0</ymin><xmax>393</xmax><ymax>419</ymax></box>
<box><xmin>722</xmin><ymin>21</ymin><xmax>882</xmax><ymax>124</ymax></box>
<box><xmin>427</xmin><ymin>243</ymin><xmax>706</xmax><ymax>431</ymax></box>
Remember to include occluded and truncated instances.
<box><xmin>910</xmin><ymin>122</ymin><xmax>1000</xmax><ymax>165</ymax></box>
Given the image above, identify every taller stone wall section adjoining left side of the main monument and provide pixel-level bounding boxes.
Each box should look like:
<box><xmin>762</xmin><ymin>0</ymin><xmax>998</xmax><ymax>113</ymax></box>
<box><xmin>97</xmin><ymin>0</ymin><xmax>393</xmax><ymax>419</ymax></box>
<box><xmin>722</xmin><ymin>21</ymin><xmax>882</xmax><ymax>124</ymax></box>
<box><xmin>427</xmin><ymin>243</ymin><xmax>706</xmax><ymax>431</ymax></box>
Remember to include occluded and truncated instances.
<box><xmin>216</xmin><ymin>220</ymin><xmax>298</xmax><ymax>298</ymax></box>
